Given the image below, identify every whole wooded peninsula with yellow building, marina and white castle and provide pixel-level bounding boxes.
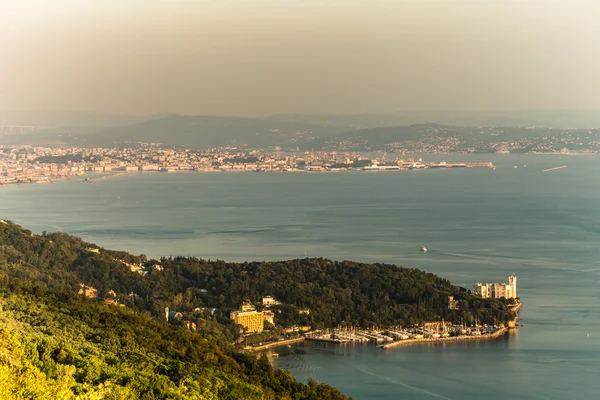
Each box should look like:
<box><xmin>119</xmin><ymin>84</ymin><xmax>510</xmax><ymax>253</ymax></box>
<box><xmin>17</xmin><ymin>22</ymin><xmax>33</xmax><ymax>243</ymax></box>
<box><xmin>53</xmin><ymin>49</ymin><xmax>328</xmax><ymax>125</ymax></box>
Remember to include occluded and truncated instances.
<box><xmin>0</xmin><ymin>220</ymin><xmax>518</xmax><ymax>360</ymax></box>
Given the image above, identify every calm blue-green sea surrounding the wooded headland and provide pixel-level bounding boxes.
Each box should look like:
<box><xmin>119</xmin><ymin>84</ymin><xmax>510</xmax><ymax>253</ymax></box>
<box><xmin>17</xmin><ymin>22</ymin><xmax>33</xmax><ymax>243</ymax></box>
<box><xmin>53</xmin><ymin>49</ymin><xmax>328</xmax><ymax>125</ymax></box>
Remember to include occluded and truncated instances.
<box><xmin>0</xmin><ymin>155</ymin><xmax>600</xmax><ymax>400</ymax></box>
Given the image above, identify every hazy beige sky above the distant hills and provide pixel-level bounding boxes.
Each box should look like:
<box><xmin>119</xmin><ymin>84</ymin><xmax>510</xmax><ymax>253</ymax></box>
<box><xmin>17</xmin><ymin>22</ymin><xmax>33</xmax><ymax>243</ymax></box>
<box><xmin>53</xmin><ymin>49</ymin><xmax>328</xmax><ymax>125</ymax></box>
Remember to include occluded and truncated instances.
<box><xmin>0</xmin><ymin>0</ymin><xmax>600</xmax><ymax>115</ymax></box>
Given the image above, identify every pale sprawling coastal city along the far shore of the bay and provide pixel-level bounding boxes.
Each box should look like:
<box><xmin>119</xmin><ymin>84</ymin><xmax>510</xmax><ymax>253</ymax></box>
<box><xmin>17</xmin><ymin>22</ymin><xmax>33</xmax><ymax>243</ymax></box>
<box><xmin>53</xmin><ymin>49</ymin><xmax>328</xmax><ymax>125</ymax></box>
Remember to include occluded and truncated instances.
<box><xmin>0</xmin><ymin>144</ymin><xmax>494</xmax><ymax>185</ymax></box>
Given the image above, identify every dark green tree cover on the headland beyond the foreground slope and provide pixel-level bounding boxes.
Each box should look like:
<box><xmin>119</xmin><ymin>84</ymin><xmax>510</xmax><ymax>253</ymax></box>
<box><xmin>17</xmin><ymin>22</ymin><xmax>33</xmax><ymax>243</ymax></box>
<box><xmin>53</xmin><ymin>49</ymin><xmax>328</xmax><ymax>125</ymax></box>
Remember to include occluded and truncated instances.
<box><xmin>0</xmin><ymin>220</ymin><xmax>512</xmax><ymax>328</ymax></box>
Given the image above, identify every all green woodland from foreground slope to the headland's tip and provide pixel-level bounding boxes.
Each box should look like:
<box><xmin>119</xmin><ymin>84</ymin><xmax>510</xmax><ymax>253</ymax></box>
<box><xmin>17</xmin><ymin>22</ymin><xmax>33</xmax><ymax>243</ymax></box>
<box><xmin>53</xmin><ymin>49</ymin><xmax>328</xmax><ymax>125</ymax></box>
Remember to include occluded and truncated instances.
<box><xmin>0</xmin><ymin>220</ymin><xmax>512</xmax><ymax>399</ymax></box>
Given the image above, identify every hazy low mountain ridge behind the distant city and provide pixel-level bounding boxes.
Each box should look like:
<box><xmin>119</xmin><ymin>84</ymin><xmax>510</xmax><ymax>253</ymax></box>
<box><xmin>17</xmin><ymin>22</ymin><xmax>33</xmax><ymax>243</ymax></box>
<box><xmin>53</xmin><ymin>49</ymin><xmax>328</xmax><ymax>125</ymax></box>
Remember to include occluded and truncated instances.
<box><xmin>0</xmin><ymin>113</ymin><xmax>600</xmax><ymax>152</ymax></box>
